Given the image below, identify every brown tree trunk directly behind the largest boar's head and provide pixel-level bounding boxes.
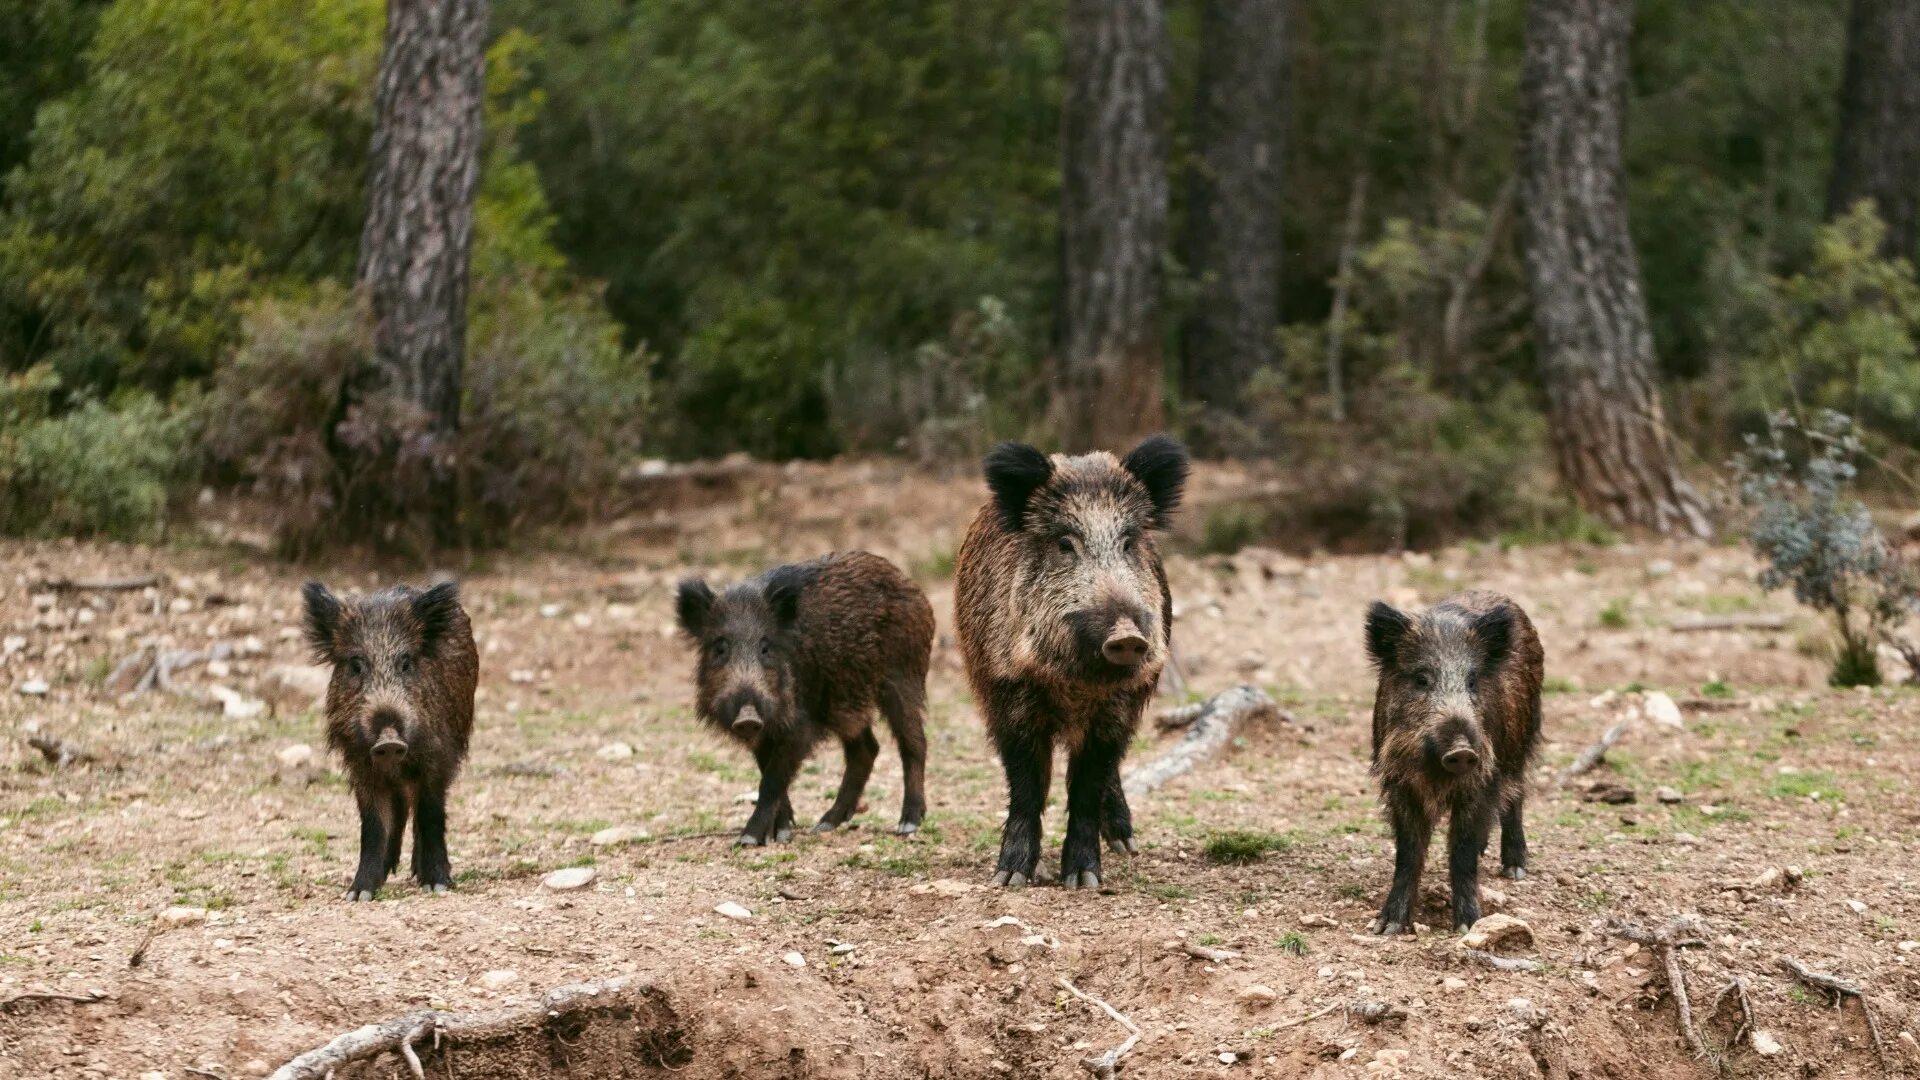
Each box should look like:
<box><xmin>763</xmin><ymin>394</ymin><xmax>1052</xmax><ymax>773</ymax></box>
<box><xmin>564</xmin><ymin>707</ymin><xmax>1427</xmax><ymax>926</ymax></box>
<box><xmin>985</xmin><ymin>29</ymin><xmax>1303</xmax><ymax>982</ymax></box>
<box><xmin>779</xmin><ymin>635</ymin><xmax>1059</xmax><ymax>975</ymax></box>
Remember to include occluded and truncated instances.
<box><xmin>1052</xmin><ymin>0</ymin><xmax>1167</xmax><ymax>450</ymax></box>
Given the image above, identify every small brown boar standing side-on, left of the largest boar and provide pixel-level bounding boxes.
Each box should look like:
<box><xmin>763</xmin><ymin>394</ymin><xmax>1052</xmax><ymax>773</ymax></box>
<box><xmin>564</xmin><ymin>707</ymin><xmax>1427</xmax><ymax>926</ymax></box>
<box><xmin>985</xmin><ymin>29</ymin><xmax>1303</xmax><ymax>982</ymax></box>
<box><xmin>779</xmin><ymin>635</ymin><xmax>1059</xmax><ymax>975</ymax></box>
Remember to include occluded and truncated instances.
<box><xmin>680</xmin><ymin>552</ymin><xmax>933</xmax><ymax>846</ymax></box>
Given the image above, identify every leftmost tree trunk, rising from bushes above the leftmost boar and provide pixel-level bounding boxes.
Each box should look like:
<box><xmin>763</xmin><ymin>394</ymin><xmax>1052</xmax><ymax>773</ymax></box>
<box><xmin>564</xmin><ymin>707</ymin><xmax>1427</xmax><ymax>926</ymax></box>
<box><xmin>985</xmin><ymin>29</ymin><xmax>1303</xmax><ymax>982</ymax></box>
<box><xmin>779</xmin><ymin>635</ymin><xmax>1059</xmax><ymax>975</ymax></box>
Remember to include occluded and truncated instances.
<box><xmin>357</xmin><ymin>0</ymin><xmax>488</xmax><ymax>440</ymax></box>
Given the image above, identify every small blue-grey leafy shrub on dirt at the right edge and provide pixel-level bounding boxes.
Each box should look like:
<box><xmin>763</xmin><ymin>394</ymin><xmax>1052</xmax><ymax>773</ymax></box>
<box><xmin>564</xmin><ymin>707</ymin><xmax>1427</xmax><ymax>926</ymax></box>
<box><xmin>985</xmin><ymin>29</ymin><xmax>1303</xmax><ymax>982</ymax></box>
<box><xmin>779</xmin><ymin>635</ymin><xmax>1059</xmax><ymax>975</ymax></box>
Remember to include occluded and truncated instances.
<box><xmin>1734</xmin><ymin>411</ymin><xmax>1916</xmax><ymax>686</ymax></box>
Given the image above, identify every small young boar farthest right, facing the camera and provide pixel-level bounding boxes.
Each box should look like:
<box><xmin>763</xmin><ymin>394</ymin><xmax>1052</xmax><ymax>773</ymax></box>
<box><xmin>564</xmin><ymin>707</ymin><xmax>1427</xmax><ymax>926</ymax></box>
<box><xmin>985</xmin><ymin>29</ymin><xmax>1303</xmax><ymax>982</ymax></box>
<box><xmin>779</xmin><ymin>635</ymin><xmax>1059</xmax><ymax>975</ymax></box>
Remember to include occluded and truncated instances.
<box><xmin>1367</xmin><ymin>592</ymin><xmax>1546</xmax><ymax>934</ymax></box>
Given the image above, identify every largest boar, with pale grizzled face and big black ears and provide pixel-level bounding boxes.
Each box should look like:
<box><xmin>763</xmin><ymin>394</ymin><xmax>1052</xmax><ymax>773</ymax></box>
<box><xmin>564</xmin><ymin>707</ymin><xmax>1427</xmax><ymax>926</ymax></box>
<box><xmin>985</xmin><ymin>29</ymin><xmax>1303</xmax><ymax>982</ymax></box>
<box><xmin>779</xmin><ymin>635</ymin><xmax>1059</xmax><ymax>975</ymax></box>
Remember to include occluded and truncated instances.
<box><xmin>954</xmin><ymin>434</ymin><xmax>1187</xmax><ymax>888</ymax></box>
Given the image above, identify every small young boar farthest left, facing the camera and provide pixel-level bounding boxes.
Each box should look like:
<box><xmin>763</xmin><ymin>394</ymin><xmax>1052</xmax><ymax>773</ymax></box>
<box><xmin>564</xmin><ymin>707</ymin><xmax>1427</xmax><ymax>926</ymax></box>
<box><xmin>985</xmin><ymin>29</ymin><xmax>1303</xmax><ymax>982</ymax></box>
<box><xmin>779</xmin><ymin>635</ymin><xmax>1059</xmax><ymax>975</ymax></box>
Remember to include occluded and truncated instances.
<box><xmin>303</xmin><ymin>582</ymin><xmax>480</xmax><ymax>899</ymax></box>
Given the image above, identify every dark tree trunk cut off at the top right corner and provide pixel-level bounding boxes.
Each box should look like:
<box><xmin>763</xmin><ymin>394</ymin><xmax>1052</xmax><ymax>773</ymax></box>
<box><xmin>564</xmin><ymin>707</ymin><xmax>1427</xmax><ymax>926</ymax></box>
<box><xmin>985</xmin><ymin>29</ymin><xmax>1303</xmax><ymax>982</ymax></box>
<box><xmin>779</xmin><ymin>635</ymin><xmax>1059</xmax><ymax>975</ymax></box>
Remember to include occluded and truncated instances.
<box><xmin>1826</xmin><ymin>0</ymin><xmax>1920</xmax><ymax>259</ymax></box>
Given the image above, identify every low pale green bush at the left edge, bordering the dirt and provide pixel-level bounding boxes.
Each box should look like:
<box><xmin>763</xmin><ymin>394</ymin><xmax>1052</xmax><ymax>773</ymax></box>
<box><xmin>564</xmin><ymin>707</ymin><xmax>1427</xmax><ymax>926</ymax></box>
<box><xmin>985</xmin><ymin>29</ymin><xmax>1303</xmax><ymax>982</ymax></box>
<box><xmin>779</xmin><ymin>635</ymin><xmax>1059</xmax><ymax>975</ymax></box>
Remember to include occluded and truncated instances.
<box><xmin>0</xmin><ymin>365</ymin><xmax>188</xmax><ymax>538</ymax></box>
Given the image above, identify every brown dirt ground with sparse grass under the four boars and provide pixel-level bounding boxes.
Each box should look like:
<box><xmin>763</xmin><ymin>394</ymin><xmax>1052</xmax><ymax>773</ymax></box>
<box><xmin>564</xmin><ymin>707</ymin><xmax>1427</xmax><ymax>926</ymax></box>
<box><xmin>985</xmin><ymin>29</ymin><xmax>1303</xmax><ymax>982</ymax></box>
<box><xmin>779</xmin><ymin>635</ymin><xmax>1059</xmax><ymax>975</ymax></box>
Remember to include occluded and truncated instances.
<box><xmin>0</xmin><ymin>455</ymin><xmax>1920</xmax><ymax>1080</ymax></box>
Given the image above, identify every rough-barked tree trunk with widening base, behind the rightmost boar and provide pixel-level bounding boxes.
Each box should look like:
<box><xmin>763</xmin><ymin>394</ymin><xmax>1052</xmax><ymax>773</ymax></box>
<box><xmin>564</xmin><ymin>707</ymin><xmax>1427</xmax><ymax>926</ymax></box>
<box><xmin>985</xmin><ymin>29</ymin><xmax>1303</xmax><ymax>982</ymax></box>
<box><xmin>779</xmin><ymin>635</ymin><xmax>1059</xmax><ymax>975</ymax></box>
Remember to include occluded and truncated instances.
<box><xmin>1521</xmin><ymin>0</ymin><xmax>1711</xmax><ymax>536</ymax></box>
